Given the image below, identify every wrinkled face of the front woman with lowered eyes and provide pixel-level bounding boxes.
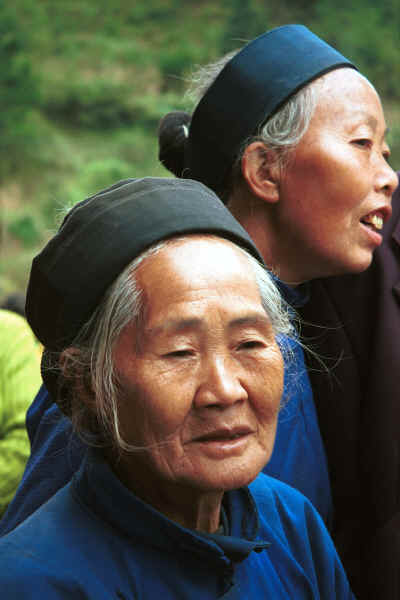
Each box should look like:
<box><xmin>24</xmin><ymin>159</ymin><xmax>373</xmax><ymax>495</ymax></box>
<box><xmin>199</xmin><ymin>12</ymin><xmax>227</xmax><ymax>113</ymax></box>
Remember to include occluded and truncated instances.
<box><xmin>114</xmin><ymin>236</ymin><xmax>283</xmax><ymax>491</ymax></box>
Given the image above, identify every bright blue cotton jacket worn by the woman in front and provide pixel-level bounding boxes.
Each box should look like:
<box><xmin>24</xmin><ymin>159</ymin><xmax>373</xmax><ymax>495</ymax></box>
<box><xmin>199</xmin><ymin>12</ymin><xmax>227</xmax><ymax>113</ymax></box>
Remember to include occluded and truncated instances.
<box><xmin>0</xmin><ymin>452</ymin><xmax>353</xmax><ymax>600</ymax></box>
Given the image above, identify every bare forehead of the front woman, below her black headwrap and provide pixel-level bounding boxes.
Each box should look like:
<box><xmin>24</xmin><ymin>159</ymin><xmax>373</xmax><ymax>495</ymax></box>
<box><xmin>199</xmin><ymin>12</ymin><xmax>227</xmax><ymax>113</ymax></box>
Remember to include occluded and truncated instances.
<box><xmin>136</xmin><ymin>235</ymin><xmax>270</xmax><ymax>331</ymax></box>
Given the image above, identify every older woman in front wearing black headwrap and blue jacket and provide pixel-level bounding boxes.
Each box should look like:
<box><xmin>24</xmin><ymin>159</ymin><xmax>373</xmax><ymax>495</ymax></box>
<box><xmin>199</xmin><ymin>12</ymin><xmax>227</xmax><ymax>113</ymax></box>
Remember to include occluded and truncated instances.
<box><xmin>0</xmin><ymin>178</ymin><xmax>352</xmax><ymax>600</ymax></box>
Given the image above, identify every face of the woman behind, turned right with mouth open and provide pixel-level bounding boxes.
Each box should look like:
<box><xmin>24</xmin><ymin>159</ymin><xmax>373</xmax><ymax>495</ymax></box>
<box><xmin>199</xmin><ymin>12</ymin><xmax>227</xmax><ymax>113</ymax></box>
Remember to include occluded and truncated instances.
<box><xmin>277</xmin><ymin>68</ymin><xmax>397</xmax><ymax>282</ymax></box>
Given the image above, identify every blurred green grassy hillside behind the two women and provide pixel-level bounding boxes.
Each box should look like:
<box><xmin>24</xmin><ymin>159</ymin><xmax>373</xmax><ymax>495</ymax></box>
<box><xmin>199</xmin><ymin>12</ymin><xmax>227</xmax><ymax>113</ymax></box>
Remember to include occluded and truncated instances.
<box><xmin>0</xmin><ymin>0</ymin><xmax>400</xmax><ymax>299</ymax></box>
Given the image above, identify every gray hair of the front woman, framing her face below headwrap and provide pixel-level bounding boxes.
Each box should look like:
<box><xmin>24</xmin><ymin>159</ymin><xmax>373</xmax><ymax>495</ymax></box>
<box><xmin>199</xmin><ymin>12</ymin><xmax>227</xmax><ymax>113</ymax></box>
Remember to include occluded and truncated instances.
<box><xmin>60</xmin><ymin>236</ymin><xmax>295</xmax><ymax>452</ymax></box>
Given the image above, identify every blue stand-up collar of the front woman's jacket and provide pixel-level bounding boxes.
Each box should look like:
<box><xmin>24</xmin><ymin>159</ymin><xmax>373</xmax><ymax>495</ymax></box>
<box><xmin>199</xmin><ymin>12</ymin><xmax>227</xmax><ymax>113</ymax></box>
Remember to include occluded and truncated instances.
<box><xmin>72</xmin><ymin>450</ymin><xmax>269</xmax><ymax>566</ymax></box>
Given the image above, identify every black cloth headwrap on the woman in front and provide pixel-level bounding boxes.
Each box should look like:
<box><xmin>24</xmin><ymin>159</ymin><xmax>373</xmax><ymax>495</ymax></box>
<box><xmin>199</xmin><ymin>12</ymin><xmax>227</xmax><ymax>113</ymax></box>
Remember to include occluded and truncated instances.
<box><xmin>26</xmin><ymin>173</ymin><xmax>262</xmax><ymax>352</ymax></box>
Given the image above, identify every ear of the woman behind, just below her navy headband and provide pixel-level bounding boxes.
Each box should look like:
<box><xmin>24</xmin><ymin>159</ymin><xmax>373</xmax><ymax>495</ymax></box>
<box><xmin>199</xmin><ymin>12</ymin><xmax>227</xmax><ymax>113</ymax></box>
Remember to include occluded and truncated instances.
<box><xmin>241</xmin><ymin>141</ymin><xmax>280</xmax><ymax>203</ymax></box>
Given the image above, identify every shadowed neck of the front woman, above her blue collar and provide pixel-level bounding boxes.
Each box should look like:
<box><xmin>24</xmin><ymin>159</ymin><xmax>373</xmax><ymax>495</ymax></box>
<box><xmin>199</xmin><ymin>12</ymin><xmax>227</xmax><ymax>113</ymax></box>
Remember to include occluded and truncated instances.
<box><xmin>111</xmin><ymin>457</ymin><xmax>224</xmax><ymax>533</ymax></box>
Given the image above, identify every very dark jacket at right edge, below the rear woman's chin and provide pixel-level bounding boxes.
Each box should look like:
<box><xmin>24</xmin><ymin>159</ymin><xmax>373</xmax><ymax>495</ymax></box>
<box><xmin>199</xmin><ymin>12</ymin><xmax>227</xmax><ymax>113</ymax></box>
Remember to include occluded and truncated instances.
<box><xmin>300</xmin><ymin>172</ymin><xmax>400</xmax><ymax>600</ymax></box>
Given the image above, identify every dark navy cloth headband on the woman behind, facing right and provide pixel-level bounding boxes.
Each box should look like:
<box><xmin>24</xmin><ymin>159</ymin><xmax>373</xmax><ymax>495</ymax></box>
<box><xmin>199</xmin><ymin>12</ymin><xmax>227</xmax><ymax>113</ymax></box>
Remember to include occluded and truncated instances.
<box><xmin>184</xmin><ymin>25</ymin><xmax>355</xmax><ymax>191</ymax></box>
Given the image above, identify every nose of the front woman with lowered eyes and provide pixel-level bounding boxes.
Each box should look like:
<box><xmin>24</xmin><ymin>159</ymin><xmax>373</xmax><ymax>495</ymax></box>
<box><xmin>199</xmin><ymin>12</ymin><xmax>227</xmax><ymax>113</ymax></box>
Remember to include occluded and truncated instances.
<box><xmin>195</xmin><ymin>355</ymin><xmax>247</xmax><ymax>409</ymax></box>
